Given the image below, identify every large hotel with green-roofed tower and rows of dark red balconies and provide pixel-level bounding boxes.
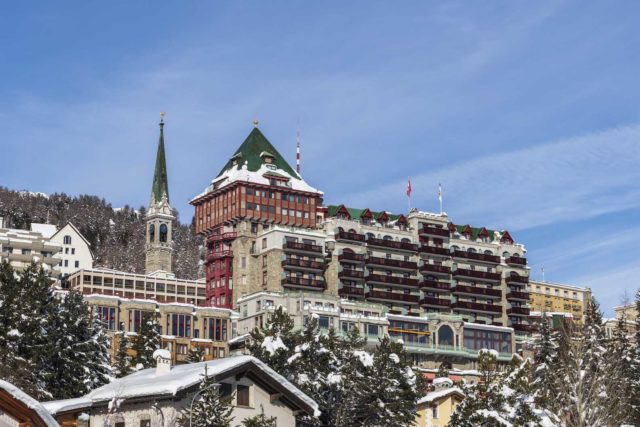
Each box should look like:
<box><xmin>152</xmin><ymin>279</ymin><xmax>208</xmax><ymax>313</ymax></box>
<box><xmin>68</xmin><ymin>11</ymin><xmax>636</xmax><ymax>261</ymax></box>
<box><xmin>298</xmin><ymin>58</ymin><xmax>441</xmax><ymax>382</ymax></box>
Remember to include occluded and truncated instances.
<box><xmin>191</xmin><ymin>126</ymin><xmax>531</xmax><ymax>344</ymax></box>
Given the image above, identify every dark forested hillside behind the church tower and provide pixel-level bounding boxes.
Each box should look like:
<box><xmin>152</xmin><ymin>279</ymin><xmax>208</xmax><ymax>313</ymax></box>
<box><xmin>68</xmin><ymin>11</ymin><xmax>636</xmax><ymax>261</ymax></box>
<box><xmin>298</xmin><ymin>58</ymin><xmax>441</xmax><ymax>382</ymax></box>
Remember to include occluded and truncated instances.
<box><xmin>0</xmin><ymin>187</ymin><xmax>201</xmax><ymax>279</ymax></box>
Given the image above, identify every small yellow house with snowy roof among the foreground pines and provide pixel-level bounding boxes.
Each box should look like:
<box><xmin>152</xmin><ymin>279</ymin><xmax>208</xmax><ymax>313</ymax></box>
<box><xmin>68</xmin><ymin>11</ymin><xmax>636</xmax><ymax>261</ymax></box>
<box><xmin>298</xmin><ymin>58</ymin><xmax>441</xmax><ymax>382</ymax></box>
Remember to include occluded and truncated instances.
<box><xmin>415</xmin><ymin>378</ymin><xmax>464</xmax><ymax>427</ymax></box>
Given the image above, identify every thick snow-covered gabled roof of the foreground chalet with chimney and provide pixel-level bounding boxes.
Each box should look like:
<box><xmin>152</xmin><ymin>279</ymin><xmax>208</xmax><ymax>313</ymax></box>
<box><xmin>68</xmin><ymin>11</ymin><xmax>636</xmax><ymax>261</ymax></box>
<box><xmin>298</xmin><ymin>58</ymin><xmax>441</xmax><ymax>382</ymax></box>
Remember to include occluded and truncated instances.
<box><xmin>45</xmin><ymin>356</ymin><xmax>318</xmax><ymax>414</ymax></box>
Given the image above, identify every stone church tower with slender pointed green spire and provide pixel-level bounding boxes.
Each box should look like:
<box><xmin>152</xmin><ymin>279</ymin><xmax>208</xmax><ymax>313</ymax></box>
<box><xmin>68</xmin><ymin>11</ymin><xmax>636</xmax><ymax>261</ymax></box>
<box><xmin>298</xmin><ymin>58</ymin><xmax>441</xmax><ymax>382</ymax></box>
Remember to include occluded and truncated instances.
<box><xmin>145</xmin><ymin>113</ymin><xmax>175</xmax><ymax>276</ymax></box>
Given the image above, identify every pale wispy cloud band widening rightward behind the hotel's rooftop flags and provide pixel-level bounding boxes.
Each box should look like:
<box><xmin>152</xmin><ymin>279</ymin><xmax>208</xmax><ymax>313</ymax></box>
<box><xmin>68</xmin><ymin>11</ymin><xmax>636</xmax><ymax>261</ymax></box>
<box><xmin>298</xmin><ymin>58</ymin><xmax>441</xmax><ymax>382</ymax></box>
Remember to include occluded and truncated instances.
<box><xmin>347</xmin><ymin>125</ymin><xmax>640</xmax><ymax>229</ymax></box>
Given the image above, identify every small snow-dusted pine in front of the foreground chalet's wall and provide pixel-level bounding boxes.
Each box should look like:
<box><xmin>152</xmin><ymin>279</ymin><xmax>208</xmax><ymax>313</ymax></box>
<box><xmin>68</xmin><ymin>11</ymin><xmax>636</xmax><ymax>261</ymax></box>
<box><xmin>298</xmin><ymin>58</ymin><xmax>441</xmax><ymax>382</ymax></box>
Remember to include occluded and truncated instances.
<box><xmin>182</xmin><ymin>366</ymin><xmax>233</xmax><ymax>427</ymax></box>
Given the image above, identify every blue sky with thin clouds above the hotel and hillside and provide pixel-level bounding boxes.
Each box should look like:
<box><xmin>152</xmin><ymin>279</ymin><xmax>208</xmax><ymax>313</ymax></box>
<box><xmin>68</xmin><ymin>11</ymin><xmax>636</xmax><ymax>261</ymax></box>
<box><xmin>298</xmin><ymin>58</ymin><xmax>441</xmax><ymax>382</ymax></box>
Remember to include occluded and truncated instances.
<box><xmin>0</xmin><ymin>1</ymin><xmax>640</xmax><ymax>313</ymax></box>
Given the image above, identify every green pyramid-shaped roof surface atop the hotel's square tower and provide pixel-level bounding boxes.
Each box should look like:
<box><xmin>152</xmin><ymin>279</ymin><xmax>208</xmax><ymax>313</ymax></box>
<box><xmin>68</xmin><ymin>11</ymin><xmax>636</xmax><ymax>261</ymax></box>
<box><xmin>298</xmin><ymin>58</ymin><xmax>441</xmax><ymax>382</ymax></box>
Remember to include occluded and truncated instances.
<box><xmin>218</xmin><ymin>127</ymin><xmax>300</xmax><ymax>179</ymax></box>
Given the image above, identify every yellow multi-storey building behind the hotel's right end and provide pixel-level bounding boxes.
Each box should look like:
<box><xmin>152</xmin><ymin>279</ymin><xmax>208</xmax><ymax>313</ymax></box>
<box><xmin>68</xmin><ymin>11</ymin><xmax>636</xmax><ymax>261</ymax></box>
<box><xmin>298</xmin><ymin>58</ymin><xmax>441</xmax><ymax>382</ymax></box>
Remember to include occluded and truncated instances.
<box><xmin>529</xmin><ymin>280</ymin><xmax>591</xmax><ymax>323</ymax></box>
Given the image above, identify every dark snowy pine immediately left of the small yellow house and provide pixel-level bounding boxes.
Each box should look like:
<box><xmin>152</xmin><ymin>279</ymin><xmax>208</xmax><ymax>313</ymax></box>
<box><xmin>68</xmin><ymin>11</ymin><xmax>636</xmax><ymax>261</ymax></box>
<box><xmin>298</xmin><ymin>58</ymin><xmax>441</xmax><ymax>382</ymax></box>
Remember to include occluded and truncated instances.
<box><xmin>360</xmin><ymin>337</ymin><xmax>418</xmax><ymax>427</ymax></box>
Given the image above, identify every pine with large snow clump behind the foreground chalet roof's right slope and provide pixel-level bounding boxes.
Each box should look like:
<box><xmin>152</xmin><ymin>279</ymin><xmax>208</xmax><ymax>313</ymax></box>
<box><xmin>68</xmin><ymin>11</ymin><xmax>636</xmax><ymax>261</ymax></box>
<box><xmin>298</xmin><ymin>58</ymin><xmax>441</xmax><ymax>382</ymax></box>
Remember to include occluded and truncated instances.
<box><xmin>247</xmin><ymin>306</ymin><xmax>300</xmax><ymax>378</ymax></box>
